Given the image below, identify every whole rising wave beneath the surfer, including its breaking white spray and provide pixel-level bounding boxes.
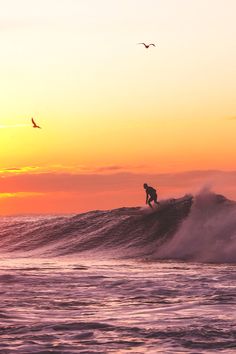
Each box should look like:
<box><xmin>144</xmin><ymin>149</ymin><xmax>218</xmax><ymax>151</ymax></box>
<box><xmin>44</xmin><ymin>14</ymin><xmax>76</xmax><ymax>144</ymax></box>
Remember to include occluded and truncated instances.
<box><xmin>0</xmin><ymin>191</ymin><xmax>236</xmax><ymax>263</ymax></box>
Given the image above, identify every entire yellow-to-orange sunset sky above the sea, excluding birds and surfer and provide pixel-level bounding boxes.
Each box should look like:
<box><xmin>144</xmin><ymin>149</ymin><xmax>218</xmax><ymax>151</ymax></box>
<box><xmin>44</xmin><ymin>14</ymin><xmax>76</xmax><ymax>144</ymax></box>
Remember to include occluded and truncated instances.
<box><xmin>0</xmin><ymin>0</ymin><xmax>236</xmax><ymax>215</ymax></box>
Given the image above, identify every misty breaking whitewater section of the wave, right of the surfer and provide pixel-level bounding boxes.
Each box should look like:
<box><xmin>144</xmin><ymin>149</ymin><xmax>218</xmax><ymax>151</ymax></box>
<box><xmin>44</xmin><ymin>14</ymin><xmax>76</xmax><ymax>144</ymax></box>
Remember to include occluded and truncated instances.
<box><xmin>155</xmin><ymin>191</ymin><xmax>236</xmax><ymax>263</ymax></box>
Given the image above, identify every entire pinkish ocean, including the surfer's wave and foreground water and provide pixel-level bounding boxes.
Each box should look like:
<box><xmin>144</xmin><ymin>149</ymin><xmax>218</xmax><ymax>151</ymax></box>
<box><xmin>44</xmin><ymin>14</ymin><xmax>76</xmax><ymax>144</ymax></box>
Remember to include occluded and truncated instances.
<box><xmin>0</xmin><ymin>192</ymin><xmax>236</xmax><ymax>354</ymax></box>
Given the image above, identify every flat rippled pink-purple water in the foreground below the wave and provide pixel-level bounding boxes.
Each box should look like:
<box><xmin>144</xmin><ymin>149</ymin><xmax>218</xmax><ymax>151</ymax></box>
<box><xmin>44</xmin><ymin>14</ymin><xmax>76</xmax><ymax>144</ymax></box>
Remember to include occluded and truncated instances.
<box><xmin>0</xmin><ymin>257</ymin><xmax>236</xmax><ymax>354</ymax></box>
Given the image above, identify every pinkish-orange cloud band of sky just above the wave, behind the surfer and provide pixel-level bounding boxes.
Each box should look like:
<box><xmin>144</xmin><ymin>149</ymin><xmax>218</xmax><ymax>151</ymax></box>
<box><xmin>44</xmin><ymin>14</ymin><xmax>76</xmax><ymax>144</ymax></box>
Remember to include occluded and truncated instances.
<box><xmin>0</xmin><ymin>171</ymin><xmax>236</xmax><ymax>215</ymax></box>
